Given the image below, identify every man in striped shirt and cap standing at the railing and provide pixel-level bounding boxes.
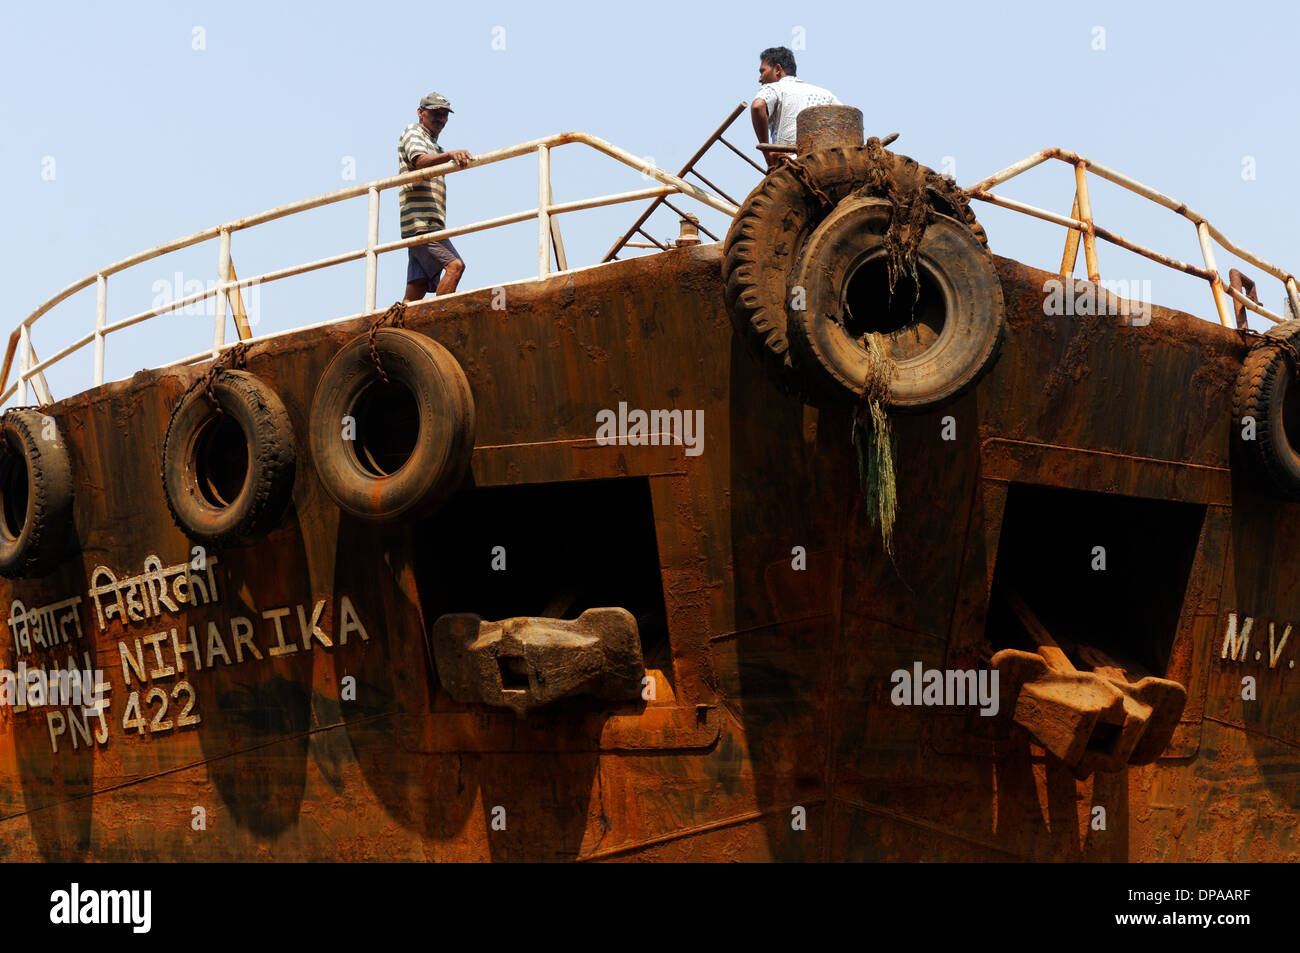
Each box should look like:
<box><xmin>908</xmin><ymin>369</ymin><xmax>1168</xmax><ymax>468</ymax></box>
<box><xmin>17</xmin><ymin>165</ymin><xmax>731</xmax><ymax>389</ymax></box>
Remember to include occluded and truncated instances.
<box><xmin>398</xmin><ymin>92</ymin><xmax>472</xmax><ymax>302</ymax></box>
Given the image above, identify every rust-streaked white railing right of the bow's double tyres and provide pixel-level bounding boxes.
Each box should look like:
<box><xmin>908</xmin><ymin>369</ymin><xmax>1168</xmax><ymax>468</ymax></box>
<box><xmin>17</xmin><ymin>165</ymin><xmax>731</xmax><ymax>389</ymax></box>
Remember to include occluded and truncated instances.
<box><xmin>966</xmin><ymin>148</ymin><xmax>1300</xmax><ymax>328</ymax></box>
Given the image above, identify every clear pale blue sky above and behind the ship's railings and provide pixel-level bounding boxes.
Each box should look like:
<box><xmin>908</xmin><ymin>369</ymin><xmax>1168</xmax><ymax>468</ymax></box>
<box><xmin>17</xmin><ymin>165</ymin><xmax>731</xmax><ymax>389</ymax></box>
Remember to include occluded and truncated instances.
<box><xmin>0</xmin><ymin>0</ymin><xmax>1300</xmax><ymax>397</ymax></box>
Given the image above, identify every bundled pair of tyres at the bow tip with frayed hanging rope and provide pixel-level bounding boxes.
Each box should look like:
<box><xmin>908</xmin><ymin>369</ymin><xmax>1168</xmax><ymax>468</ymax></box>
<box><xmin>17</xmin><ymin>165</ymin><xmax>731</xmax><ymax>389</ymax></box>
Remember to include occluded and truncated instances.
<box><xmin>723</xmin><ymin>138</ymin><xmax>1005</xmax><ymax>558</ymax></box>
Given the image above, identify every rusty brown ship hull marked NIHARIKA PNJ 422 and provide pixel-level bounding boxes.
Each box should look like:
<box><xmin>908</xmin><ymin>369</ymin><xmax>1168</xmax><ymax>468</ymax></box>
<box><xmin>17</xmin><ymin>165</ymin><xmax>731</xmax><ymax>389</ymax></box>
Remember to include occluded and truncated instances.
<box><xmin>0</xmin><ymin>234</ymin><xmax>1300</xmax><ymax>861</ymax></box>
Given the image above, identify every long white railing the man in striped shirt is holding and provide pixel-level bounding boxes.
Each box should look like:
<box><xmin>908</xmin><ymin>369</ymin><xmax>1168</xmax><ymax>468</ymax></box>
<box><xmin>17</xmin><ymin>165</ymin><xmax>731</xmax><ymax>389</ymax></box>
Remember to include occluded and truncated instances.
<box><xmin>0</xmin><ymin>133</ymin><xmax>738</xmax><ymax>404</ymax></box>
